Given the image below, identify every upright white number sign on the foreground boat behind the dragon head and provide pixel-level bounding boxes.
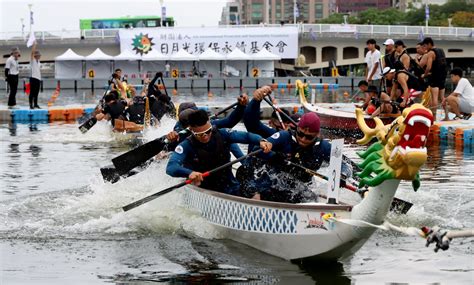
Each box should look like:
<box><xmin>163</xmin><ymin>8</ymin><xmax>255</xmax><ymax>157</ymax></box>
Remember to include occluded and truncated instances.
<box><xmin>327</xmin><ymin>139</ymin><xmax>344</xmax><ymax>204</ymax></box>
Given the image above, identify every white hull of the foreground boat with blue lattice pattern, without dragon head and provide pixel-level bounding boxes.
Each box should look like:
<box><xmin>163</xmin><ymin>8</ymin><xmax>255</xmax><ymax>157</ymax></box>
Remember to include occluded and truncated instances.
<box><xmin>181</xmin><ymin>180</ymin><xmax>398</xmax><ymax>260</ymax></box>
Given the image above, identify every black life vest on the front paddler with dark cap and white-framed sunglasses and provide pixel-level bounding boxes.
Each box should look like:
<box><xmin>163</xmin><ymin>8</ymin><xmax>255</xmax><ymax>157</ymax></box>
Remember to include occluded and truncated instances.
<box><xmin>186</xmin><ymin>127</ymin><xmax>232</xmax><ymax>192</ymax></box>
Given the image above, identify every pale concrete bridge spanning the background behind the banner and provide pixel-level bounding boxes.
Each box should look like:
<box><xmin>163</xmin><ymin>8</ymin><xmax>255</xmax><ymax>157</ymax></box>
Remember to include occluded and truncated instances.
<box><xmin>0</xmin><ymin>24</ymin><xmax>474</xmax><ymax>74</ymax></box>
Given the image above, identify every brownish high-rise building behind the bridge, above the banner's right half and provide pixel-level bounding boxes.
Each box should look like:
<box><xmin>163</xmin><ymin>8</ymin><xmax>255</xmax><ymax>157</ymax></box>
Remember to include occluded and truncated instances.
<box><xmin>238</xmin><ymin>0</ymin><xmax>336</xmax><ymax>25</ymax></box>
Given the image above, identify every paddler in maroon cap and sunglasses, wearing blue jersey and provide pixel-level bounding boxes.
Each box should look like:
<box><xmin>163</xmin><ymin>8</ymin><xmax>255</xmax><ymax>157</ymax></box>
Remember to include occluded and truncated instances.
<box><xmin>241</xmin><ymin>112</ymin><xmax>352</xmax><ymax>203</ymax></box>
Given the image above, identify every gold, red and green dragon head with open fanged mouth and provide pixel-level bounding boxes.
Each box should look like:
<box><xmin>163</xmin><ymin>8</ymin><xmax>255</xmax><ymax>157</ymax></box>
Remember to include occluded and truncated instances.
<box><xmin>356</xmin><ymin>104</ymin><xmax>433</xmax><ymax>191</ymax></box>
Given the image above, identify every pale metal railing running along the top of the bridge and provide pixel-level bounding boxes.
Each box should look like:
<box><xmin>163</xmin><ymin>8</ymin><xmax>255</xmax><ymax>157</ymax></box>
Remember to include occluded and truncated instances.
<box><xmin>0</xmin><ymin>24</ymin><xmax>474</xmax><ymax>41</ymax></box>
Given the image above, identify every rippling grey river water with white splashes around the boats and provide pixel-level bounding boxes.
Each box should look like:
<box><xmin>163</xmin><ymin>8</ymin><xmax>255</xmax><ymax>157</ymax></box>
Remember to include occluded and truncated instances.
<box><xmin>0</xmin><ymin>88</ymin><xmax>474</xmax><ymax>284</ymax></box>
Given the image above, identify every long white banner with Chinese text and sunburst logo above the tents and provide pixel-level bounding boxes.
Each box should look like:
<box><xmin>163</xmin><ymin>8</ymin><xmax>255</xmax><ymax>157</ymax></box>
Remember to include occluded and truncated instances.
<box><xmin>119</xmin><ymin>26</ymin><xmax>298</xmax><ymax>58</ymax></box>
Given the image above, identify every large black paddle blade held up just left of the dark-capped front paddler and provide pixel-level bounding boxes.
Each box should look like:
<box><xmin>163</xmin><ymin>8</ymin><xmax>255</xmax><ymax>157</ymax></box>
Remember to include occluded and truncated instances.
<box><xmin>112</xmin><ymin>137</ymin><xmax>166</xmax><ymax>175</ymax></box>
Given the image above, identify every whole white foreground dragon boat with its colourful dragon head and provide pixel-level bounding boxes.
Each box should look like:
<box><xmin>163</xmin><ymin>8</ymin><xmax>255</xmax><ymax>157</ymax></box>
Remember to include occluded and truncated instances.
<box><xmin>179</xmin><ymin>104</ymin><xmax>433</xmax><ymax>260</ymax></box>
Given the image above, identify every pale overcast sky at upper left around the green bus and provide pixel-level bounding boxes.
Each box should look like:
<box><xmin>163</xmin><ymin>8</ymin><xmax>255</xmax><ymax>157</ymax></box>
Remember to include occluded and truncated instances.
<box><xmin>0</xmin><ymin>0</ymin><xmax>227</xmax><ymax>32</ymax></box>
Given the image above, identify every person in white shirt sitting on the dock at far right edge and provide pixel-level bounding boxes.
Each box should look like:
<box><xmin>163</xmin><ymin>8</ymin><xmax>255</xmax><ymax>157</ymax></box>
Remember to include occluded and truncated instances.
<box><xmin>441</xmin><ymin>67</ymin><xmax>474</xmax><ymax>121</ymax></box>
